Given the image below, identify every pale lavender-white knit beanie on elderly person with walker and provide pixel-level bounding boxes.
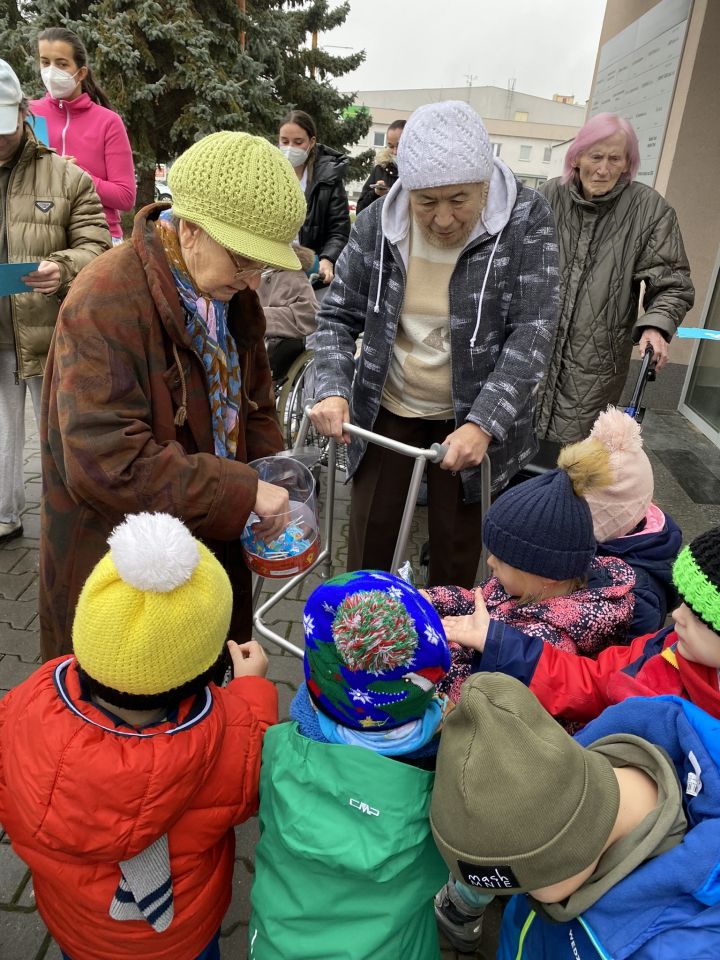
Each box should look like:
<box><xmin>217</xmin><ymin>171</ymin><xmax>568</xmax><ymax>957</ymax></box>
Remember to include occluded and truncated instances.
<box><xmin>397</xmin><ymin>100</ymin><xmax>493</xmax><ymax>190</ymax></box>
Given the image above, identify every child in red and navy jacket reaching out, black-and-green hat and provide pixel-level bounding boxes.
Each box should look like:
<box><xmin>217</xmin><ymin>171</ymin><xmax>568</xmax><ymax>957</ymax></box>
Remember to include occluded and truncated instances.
<box><xmin>443</xmin><ymin>527</ymin><xmax>720</xmax><ymax>723</ymax></box>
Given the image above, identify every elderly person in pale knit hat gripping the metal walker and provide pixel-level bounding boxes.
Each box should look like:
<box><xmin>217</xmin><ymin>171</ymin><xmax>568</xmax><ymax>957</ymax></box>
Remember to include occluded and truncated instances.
<box><xmin>312</xmin><ymin>101</ymin><xmax>558</xmax><ymax>587</ymax></box>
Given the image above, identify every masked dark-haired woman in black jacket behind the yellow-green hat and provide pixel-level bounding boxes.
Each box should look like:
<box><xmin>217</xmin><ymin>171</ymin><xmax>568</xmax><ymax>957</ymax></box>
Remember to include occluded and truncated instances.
<box><xmin>278</xmin><ymin>110</ymin><xmax>350</xmax><ymax>284</ymax></box>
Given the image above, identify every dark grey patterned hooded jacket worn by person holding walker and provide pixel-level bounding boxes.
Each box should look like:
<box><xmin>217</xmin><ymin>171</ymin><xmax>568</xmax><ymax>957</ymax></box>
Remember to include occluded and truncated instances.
<box><xmin>316</xmin><ymin>160</ymin><xmax>558</xmax><ymax>502</ymax></box>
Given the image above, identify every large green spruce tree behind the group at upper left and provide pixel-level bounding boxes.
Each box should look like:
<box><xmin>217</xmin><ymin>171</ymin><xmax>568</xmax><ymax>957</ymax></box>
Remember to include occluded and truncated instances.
<box><xmin>0</xmin><ymin>0</ymin><xmax>370</xmax><ymax>204</ymax></box>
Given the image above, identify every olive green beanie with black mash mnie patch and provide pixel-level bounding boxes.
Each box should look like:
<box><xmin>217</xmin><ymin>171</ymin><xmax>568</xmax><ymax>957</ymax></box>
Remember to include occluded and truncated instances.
<box><xmin>430</xmin><ymin>673</ymin><xmax>620</xmax><ymax>893</ymax></box>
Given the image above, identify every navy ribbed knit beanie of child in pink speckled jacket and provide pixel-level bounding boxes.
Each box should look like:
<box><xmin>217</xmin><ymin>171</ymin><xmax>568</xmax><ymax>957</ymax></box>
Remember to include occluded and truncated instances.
<box><xmin>483</xmin><ymin>470</ymin><xmax>597</xmax><ymax>580</ymax></box>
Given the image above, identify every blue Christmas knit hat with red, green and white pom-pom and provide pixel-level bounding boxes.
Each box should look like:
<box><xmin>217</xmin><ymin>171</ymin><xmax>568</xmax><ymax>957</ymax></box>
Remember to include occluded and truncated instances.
<box><xmin>303</xmin><ymin>570</ymin><xmax>450</xmax><ymax>730</ymax></box>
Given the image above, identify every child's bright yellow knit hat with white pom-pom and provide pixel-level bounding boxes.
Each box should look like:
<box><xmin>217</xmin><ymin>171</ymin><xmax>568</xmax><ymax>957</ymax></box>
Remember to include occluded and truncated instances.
<box><xmin>73</xmin><ymin>513</ymin><xmax>232</xmax><ymax>706</ymax></box>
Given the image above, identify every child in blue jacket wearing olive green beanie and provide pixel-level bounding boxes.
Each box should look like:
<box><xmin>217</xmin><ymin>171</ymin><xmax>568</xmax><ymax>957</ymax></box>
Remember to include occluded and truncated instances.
<box><xmin>430</xmin><ymin>674</ymin><xmax>720</xmax><ymax>960</ymax></box>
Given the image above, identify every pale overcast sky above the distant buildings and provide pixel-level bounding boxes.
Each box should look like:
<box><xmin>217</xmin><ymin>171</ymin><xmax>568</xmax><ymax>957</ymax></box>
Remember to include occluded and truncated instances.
<box><xmin>318</xmin><ymin>0</ymin><xmax>605</xmax><ymax>103</ymax></box>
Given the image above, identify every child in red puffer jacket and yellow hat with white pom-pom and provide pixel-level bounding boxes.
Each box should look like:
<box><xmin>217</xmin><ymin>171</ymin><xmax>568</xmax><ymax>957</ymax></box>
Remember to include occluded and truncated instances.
<box><xmin>0</xmin><ymin>514</ymin><xmax>277</xmax><ymax>960</ymax></box>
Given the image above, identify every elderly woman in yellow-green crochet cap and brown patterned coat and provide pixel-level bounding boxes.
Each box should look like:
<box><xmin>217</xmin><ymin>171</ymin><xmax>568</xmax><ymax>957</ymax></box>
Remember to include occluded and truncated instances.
<box><xmin>40</xmin><ymin>132</ymin><xmax>305</xmax><ymax>659</ymax></box>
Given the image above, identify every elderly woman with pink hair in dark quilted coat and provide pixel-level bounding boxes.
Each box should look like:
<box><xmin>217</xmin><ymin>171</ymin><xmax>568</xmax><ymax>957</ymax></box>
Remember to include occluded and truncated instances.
<box><xmin>537</xmin><ymin>113</ymin><xmax>694</xmax><ymax>443</ymax></box>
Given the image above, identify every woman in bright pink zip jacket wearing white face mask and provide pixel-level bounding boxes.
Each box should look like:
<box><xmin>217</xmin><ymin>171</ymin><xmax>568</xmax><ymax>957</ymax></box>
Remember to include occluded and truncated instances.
<box><xmin>30</xmin><ymin>27</ymin><xmax>135</xmax><ymax>243</ymax></box>
